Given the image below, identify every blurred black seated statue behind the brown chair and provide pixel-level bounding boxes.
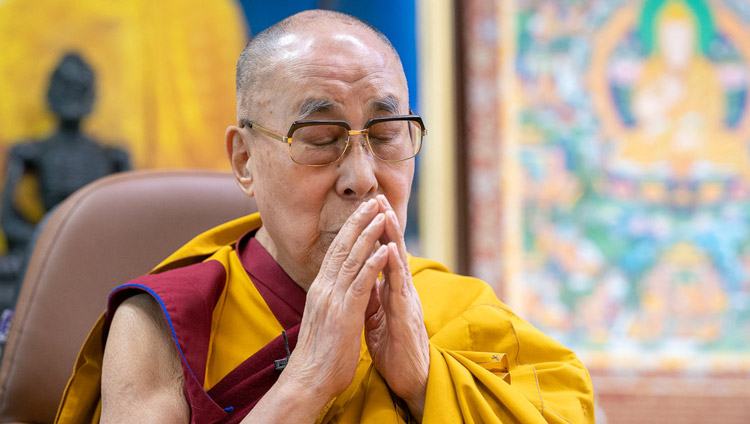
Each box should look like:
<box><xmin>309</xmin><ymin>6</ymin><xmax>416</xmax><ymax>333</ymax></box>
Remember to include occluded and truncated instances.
<box><xmin>0</xmin><ymin>53</ymin><xmax>130</xmax><ymax>303</ymax></box>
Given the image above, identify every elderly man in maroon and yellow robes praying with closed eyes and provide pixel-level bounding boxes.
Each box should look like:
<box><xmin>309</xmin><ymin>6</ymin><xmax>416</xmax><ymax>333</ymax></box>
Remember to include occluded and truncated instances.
<box><xmin>58</xmin><ymin>11</ymin><xmax>593</xmax><ymax>423</ymax></box>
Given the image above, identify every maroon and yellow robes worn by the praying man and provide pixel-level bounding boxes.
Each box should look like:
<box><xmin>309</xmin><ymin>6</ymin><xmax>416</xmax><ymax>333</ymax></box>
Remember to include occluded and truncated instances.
<box><xmin>56</xmin><ymin>214</ymin><xmax>594</xmax><ymax>424</ymax></box>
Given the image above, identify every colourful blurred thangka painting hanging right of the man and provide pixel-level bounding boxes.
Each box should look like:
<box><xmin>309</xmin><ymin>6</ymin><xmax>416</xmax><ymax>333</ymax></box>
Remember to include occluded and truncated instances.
<box><xmin>511</xmin><ymin>0</ymin><xmax>750</xmax><ymax>371</ymax></box>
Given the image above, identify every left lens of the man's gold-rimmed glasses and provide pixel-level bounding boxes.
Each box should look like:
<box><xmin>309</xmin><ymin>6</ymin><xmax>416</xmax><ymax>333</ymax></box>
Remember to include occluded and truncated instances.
<box><xmin>291</xmin><ymin>124</ymin><xmax>349</xmax><ymax>165</ymax></box>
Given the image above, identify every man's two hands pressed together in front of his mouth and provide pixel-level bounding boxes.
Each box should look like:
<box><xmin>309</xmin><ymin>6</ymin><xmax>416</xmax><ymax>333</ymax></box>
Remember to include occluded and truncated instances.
<box><xmin>280</xmin><ymin>195</ymin><xmax>430</xmax><ymax>418</ymax></box>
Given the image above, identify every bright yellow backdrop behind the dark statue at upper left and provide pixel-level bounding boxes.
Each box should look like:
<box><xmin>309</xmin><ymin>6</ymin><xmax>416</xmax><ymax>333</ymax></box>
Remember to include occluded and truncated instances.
<box><xmin>0</xmin><ymin>0</ymin><xmax>246</xmax><ymax>169</ymax></box>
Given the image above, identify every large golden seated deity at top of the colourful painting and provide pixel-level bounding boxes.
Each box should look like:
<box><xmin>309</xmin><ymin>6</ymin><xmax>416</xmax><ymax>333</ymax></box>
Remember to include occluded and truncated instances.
<box><xmin>618</xmin><ymin>0</ymin><xmax>750</xmax><ymax>180</ymax></box>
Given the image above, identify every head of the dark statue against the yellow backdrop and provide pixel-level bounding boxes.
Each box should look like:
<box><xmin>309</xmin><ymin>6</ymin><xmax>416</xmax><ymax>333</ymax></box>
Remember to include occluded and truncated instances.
<box><xmin>47</xmin><ymin>53</ymin><xmax>96</xmax><ymax>121</ymax></box>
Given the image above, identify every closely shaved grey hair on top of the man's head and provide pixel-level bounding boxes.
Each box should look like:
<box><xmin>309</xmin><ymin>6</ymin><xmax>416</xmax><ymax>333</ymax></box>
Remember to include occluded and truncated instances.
<box><xmin>236</xmin><ymin>10</ymin><xmax>403</xmax><ymax>116</ymax></box>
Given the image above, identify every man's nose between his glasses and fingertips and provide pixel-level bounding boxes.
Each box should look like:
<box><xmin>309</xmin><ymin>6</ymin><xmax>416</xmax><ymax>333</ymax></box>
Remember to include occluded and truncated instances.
<box><xmin>336</xmin><ymin>134</ymin><xmax>379</xmax><ymax>200</ymax></box>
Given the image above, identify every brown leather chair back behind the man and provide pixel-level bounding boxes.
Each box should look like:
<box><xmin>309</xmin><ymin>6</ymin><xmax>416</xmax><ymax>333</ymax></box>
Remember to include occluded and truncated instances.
<box><xmin>0</xmin><ymin>171</ymin><xmax>255</xmax><ymax>423</ymax></box>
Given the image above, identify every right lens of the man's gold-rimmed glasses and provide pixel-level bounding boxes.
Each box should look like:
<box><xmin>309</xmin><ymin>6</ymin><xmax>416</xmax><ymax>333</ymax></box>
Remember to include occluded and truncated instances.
<box><xmin>368</xmin><ymin>121</ymin><xmax>422</xmax><ymax>161</ymax></box>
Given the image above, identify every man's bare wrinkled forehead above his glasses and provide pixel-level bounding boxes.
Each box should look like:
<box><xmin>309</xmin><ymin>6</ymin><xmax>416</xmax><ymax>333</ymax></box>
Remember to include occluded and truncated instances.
<box><xmin>256</xmin><ymin>24</ymin><xmax>408</xmax><ymax>119</ymax></box>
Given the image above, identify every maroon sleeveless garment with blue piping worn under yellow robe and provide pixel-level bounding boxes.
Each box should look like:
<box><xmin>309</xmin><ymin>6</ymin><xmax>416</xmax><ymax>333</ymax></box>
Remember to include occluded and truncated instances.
<box><xmin>104</xmin><ymin>232</ymin><xmax>306</xmax><ymax>424</ymax></box>
